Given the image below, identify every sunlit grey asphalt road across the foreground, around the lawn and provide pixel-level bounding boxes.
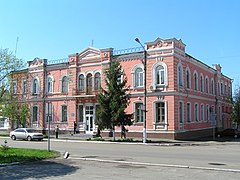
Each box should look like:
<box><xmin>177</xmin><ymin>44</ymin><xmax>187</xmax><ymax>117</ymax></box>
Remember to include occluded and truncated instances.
<box><xmin>0</xmin><ymin>139</ymin><xmax>240</xmax><ymax>180</ymax></box>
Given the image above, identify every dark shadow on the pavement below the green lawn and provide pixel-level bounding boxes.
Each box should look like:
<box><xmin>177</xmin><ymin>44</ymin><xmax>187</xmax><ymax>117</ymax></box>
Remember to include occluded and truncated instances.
<box><xmin>0</xmin><ymin>159</ymin><xmax>79</xmax><ymax>180</ymax></box>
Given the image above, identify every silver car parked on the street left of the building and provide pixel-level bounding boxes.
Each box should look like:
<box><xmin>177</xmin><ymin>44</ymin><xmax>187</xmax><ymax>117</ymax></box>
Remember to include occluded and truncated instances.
<box><xmin>10</xmin><ymin>128</ymin><xmax>43</xmax><ymax>141</ymax></box>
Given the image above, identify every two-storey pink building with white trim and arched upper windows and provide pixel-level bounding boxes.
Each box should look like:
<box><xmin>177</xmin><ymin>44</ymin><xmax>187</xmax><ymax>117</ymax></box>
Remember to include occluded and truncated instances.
<box><xmin>12</xmin><ymin>38</ymin><xmax>232</xmax><ymax>139</ymax></box>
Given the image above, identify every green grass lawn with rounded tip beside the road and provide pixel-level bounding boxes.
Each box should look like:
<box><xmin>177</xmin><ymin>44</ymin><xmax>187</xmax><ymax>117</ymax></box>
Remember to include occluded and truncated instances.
<box><xmin>0</xmin><ymin>146</ymin><xmax>59</xmax><ymax>164</ymax></box>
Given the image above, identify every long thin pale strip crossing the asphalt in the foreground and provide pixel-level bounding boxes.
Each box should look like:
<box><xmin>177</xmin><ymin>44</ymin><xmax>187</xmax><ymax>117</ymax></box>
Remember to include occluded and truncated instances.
<box><xmin>69</xmin><ymin>157</ymin><xmax>240</xmax><ymax>173</ymax></box>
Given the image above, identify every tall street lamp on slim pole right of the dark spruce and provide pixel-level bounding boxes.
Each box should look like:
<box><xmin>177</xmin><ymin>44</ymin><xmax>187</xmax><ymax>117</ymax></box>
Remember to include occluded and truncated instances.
<box><xmin>135</xmin><ymin>38</ymin><xmax>147</xmax><ymax>143</ymax></box>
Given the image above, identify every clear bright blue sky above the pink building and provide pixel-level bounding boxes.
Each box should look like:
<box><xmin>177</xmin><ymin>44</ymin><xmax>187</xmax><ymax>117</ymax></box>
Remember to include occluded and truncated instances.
<box><xmin>0</xmin><ymin>0</ymin><xmax>240</xmax><ymax>90</ymax></box>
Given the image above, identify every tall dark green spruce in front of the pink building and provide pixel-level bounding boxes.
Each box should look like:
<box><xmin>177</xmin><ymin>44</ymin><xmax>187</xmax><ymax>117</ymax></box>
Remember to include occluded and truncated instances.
<box><xmin>96</xmin><ymin>61</ymin><xmax>132</xmax><ymax>139</ymax></box>
